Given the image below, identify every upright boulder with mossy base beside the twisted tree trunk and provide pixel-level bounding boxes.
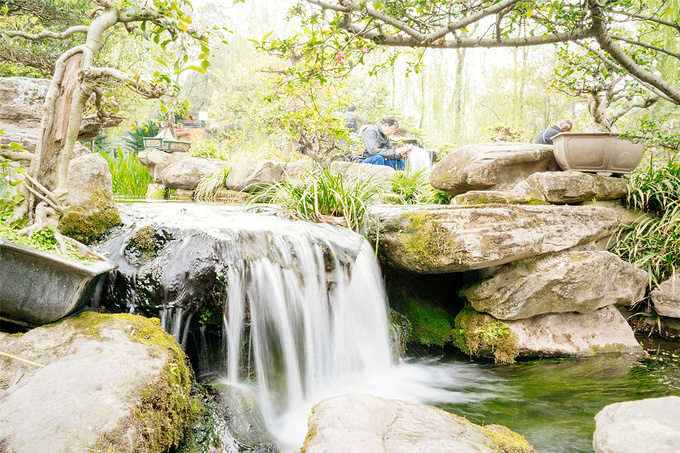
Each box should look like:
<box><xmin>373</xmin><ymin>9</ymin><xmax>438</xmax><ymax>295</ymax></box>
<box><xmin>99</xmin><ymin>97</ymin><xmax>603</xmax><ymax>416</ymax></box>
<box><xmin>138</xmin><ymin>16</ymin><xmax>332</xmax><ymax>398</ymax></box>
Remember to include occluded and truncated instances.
<box><xmin>59</xmin><ymin>153</ymin><xmax>121</xmax><ymax>244</ymax></box>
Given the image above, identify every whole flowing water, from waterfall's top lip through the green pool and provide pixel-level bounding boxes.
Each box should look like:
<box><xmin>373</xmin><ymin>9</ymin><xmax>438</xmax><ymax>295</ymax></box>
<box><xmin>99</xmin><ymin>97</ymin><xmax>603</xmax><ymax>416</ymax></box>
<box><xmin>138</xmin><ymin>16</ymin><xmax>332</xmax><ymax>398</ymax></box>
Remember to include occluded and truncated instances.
<box><xmin>100</xmin><ymin>203</ymin><xmax>680</xmax><ymax>453</ymax></box>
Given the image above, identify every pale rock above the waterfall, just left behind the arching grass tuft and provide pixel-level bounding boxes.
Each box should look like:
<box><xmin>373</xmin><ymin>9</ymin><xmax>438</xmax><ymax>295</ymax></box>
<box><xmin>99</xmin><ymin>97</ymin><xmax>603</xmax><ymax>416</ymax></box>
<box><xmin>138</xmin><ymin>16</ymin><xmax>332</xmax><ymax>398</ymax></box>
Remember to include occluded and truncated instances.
<box><xmin>225</xmin><ymin>157</ymin><xmax>287</xmax><ymax>192</ymax></box>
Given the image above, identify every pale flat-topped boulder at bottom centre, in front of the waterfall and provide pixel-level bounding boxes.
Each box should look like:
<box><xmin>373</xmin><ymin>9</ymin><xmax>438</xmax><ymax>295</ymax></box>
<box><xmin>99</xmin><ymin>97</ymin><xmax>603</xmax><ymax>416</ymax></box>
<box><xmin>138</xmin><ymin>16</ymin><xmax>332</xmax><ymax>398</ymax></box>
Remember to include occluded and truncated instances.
<box><xmin>302</xmin><ymin>394</ymin><xmax>535</xmax><ymax>453</ymax></box>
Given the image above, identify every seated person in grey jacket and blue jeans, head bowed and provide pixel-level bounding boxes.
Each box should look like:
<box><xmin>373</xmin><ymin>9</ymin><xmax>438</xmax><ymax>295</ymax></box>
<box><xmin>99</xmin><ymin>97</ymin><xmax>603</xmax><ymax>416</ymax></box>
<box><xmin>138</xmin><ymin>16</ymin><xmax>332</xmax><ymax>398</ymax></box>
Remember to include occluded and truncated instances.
<box><xmin>360</xmin><ymin>115</ymin><xmax>413</xmax><ymax>170</ymax></box>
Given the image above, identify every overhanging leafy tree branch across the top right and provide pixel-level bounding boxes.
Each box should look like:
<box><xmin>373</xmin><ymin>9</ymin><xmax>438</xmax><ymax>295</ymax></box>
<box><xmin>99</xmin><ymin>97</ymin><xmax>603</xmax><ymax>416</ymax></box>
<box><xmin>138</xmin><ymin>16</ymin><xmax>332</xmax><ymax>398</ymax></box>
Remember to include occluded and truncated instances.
<box><xmin>296</xmin><ymin>0</ymin><xmax>680</xmax><ymax>104</ymax></box>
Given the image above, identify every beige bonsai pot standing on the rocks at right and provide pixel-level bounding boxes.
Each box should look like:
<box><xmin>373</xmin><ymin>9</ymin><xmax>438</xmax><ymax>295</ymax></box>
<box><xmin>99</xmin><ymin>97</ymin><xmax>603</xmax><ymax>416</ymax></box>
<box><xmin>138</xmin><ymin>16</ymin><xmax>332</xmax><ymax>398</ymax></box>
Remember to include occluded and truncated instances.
<box><xmin>552</xmin><ymin>132</ymin><xmax>645</xmax><ymax>176</ymax></box>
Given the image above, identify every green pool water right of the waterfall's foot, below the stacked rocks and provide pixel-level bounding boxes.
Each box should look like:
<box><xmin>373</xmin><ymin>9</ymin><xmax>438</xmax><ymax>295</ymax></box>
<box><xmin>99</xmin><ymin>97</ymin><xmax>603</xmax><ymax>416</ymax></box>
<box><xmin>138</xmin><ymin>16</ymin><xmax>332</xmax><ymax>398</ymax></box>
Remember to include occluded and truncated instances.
<box><xmin>428</xmin><ymin>352</ymin><xmax>680</xmax><ymax>453</ymax></box>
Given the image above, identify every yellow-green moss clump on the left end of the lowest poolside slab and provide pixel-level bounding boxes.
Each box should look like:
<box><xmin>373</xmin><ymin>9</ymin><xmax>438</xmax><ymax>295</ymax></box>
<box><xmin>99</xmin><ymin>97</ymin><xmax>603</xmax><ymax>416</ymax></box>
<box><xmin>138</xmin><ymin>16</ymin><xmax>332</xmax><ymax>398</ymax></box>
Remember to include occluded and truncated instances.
<box><xmin>453</xmin><ymin>306</ymin><xmax>519</xmax><ymax>363</ymax></box>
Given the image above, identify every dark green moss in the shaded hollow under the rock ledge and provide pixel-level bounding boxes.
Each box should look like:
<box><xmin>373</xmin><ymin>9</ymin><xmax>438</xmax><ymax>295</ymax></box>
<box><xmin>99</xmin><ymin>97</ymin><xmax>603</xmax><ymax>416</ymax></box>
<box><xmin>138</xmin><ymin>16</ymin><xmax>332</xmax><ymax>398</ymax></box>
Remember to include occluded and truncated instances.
<box><xmin>402</xmin><ymin>298</ymin><xmax>454</xmax><ymax>346</ymax></box>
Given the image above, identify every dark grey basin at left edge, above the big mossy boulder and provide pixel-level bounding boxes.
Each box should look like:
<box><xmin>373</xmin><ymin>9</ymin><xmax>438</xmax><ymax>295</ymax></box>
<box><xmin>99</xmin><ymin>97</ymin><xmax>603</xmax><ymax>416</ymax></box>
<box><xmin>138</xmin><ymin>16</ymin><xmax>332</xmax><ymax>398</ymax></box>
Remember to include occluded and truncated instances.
<box><xmin>0</xmin><ymin>237</ymin><xmax>116</xmax><ymax>327</ymax></box>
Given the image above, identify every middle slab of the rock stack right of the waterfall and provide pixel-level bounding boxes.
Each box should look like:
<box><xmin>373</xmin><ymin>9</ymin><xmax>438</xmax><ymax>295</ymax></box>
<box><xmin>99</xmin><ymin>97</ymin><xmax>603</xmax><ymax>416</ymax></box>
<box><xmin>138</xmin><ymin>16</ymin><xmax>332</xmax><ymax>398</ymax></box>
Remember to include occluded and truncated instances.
<box><xmin>464</xmin><ymin>250</ymin><xmax>648</xmax><ymax>319</ymax></box>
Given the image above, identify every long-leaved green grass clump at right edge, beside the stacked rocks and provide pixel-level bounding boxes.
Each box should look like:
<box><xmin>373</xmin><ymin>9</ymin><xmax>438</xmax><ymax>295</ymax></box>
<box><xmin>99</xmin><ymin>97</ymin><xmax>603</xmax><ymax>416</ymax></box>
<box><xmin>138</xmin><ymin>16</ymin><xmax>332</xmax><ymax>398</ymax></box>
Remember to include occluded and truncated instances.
<box><xmin>613</xmin><ymin>155</ymin><xmax>680</xmax><ymax>289</ymax></box>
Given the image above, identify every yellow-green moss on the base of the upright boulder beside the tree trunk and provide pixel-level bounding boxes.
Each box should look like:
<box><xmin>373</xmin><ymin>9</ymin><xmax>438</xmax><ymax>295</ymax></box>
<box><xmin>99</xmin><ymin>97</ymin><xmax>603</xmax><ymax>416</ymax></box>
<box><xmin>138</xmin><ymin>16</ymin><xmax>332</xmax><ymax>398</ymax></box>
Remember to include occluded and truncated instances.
<box><xmin>59</xmin><ymin>187</ymin><xmax>121</xmax><ymax>244</ymax></box>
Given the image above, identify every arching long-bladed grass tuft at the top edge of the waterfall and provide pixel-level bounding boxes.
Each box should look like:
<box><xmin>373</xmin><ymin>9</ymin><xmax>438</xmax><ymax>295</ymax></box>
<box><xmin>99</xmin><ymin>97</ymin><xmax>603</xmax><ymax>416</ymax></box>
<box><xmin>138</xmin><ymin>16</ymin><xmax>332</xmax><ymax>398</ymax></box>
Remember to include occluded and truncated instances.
<box><xmin>249</xmin><ymin>168</ymin><xmax>377</xmax><ymax>231</ymax></box>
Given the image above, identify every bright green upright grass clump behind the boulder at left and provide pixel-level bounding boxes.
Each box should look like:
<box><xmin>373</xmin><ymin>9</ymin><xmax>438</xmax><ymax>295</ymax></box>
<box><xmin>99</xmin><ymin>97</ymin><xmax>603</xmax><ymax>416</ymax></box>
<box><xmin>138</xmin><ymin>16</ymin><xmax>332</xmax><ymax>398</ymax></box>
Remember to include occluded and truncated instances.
<box><xmin>101</xmin><ymin>148</ymin><xmax>153</xmax><ymax>197</ymax></box>
